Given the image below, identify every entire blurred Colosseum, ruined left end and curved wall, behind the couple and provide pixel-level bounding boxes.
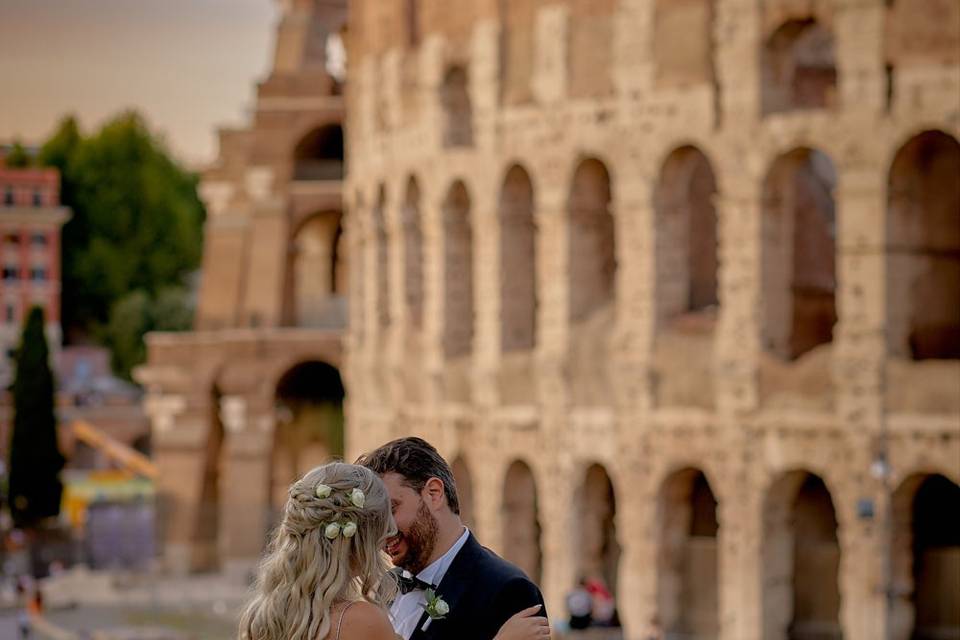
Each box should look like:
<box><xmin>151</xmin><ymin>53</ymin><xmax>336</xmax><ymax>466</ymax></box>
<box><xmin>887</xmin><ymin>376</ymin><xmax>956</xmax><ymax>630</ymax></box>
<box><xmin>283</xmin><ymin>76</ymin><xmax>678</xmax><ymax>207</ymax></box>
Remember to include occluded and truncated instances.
<box><xmin>142</xmin><ymin>0</ymin><xmax>960</xmax><ymax>640</ymax></box>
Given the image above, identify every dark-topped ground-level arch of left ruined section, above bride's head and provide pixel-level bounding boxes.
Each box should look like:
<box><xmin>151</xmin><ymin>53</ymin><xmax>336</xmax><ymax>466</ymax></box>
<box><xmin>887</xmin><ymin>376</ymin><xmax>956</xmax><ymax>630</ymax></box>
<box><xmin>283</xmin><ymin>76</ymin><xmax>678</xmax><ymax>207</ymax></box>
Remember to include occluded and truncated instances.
<box><xmin>269</xmin><ymin>360</ymin><xmax>345</xmax><ymax>525</ymax></box>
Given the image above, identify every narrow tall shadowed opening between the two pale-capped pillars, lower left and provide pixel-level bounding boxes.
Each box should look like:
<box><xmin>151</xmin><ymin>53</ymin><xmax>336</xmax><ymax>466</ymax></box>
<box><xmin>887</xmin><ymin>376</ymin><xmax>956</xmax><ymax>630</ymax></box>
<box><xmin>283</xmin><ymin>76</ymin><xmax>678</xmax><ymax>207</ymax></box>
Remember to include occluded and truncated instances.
<box><xmin>190</xmin><ymin>386</ymin><xmax>225</xmax><ymax>571</ymax></box>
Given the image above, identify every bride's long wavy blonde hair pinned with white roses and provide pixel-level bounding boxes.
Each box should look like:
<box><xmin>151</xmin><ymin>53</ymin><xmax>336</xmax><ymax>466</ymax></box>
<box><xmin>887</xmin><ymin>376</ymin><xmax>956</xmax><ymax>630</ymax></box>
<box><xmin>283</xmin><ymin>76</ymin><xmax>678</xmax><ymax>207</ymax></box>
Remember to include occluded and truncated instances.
<box><xmin>240</xmin><ymin>462</ymin><xmax>396</xmax><ymax>640</ymax></box>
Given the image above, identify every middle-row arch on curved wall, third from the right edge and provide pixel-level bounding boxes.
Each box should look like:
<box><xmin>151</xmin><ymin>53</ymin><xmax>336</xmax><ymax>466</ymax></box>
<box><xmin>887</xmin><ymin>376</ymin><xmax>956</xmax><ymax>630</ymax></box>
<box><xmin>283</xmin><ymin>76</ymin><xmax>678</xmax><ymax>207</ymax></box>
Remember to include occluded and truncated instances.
<box><xmin>654</xmin><ymin>145</ymin><xmax>719</xmax><ymax>320</ymax></box>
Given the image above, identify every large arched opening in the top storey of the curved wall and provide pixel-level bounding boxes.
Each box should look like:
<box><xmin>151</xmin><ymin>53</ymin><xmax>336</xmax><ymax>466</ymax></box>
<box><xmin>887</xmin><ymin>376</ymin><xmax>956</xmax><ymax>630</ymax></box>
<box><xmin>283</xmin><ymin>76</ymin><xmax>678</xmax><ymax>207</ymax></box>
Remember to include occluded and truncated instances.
<box><xmin>760</xmin><ymin>16</ymin><xmax>837</xmax><ymax>114</ymax></box>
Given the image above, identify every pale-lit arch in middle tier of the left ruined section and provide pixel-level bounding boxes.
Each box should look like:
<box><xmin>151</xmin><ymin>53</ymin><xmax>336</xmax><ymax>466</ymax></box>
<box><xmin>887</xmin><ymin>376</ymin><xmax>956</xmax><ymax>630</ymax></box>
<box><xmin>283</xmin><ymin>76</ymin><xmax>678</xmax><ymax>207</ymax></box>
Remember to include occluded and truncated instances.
<box><xmin>290</xmin><ymin>211</ymin><xmax>346</xmax><ymax>328</ymax></box>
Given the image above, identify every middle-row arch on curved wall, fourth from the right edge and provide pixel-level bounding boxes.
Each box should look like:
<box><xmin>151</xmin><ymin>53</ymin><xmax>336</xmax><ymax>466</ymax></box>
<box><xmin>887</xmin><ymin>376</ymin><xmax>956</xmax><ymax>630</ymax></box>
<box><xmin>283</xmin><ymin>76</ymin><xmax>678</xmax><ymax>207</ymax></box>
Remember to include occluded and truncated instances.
<box><xmin>567</xmin><ymin>158</ymin><xmax>617</xmax><ymax>323</ymax></box>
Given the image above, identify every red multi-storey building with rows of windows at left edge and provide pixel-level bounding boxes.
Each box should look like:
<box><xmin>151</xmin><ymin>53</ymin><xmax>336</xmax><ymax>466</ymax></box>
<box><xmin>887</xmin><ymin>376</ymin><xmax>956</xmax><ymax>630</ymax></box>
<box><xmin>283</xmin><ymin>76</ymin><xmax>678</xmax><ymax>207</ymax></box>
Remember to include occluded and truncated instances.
<box><xmin>0</xmin><ymin>165</ymin><xmax>70</xmax><ymax>386</ymax></box>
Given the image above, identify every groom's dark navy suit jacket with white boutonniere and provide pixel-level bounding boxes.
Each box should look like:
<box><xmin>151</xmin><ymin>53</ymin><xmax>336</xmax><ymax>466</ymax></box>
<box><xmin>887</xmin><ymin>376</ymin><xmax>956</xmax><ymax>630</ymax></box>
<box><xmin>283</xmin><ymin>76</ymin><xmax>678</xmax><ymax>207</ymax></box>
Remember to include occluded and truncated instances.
<box><xmin>410</xmin><ymin>533</ymin><xmax>547</xmax><ymax>640</ymax></box>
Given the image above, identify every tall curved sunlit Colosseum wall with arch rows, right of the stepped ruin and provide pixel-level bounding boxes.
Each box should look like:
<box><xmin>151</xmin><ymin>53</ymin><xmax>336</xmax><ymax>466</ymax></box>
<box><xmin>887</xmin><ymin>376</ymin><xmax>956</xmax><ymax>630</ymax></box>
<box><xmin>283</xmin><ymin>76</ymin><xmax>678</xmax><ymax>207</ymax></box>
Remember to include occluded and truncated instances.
<box><xmin>345</xmin><ymin>0</ymin><xmax>960</xmax><ymax>640</ymax></box>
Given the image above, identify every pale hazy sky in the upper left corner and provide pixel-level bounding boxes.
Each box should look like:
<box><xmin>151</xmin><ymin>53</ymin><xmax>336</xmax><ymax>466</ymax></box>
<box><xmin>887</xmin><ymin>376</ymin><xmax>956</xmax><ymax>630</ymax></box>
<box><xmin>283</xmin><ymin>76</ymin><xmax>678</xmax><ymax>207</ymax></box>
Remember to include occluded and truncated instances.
<box><xmin>0</xmin><ymin>0</ymin><xmax>279</xmax><ymax>168</ymax></box>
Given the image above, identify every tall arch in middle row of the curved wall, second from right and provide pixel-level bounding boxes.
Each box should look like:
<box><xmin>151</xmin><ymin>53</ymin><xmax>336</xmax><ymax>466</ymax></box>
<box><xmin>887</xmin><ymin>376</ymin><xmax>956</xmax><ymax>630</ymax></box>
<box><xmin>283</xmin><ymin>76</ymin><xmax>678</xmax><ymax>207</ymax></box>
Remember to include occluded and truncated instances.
<box><xmin>761</xmin><ymin>148</ymin><xmax>837</xmax><ymax>359</ymax></box>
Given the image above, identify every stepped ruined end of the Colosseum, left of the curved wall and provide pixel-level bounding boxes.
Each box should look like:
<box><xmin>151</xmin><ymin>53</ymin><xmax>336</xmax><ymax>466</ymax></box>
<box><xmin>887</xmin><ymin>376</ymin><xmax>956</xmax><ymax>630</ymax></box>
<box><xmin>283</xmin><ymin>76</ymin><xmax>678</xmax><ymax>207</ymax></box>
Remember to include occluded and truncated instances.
<box><xmin>137</xmin><ymin>0</ymin><xmax>347</xmax><ymax>571</ymax></box>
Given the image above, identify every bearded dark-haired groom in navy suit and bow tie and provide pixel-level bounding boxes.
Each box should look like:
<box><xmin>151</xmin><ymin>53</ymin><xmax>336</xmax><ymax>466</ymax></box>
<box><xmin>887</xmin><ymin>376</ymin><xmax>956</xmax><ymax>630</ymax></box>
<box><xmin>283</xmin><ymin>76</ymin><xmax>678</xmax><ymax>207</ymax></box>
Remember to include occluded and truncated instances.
<box><xmin>357</xmin><ymin>438</ymin><xmax>546</xmax><ymax>640</ymax></box>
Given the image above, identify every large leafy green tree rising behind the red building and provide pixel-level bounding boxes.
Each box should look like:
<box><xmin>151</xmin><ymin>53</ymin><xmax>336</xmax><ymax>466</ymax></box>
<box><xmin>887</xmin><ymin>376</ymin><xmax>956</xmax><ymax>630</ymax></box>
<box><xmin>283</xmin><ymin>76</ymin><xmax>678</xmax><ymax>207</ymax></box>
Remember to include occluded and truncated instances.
<box><xmin>39</xmin><ymin>113</ymin><xmax>204</xmax><ymax>341</ymax></box>
